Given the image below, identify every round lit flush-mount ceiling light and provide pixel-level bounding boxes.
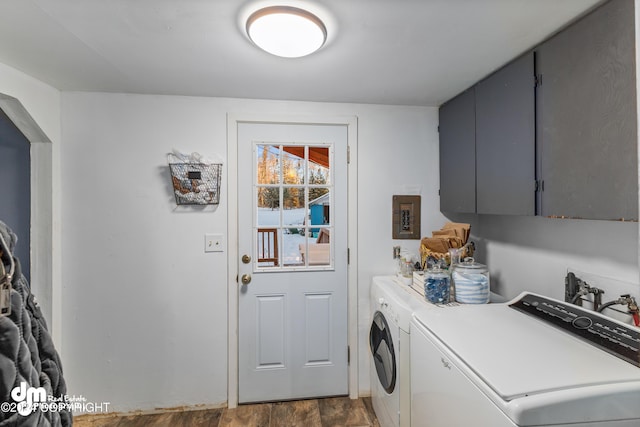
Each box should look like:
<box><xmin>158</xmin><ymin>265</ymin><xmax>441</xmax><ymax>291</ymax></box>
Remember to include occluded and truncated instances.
<box><xmin>246</xmin><ymin>6</ymin><xmax>327</xmax><ymax>58</ymax></box>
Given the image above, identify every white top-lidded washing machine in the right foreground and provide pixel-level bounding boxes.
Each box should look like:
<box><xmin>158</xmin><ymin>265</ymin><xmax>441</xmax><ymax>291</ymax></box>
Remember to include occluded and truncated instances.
<box><xmin>411</xmin><ymin>293</ymin><xmax>640</xmax><ymax>427</ymax></box>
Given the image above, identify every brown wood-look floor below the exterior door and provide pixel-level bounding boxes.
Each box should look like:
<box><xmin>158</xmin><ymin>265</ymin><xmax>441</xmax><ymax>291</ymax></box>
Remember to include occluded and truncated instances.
<box><xmin>73</xmin><ymin>397</ymin><xmax>380</xmax><ymax>427</ymax></box>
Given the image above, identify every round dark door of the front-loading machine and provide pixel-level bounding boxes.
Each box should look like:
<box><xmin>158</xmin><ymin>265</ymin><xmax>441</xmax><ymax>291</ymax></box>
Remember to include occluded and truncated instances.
<box><xmin>369</xmin><ymin>311</ymin><xmax>396</xmax><ymax>394</ymax></box>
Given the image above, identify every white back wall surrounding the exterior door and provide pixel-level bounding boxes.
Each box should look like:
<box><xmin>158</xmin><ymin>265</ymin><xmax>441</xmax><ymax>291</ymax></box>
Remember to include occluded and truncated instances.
<box><xmin>61</xmin><ymin>93</ymin><xmax>442</xmax><ymax>411</ymax></box>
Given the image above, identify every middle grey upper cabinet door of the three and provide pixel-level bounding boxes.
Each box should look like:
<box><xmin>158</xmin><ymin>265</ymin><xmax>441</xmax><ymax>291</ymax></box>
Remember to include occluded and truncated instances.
<box><xmin>476</xmin><ymin>52</ymin><xmax>536</xmax><ymax>215</ymax></box>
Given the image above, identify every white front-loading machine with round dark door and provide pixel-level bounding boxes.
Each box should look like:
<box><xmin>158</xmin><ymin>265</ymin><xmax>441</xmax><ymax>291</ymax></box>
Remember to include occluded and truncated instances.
<box><xmin>369</xmin><ymin>276</ymin><xmax>425</xmax><ymax>427</ymax></box>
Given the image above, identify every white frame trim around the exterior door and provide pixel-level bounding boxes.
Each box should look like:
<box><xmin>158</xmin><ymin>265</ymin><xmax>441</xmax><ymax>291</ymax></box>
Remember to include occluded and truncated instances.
<box><xmin>227</xmin><ymin>113</ymin><xmax>358</xmax><ymax>408</ymax></box>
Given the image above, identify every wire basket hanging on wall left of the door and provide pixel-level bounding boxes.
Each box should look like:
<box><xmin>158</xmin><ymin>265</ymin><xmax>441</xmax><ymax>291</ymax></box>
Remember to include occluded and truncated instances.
<box><xmin>169</xmin><ymin>156</ymin><xmax>222</xmax><ymax>205</ymax></box>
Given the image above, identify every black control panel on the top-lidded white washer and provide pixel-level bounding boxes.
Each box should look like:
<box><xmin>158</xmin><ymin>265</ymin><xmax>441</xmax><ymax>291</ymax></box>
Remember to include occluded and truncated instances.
<box><xmin>509</xmin><ymin>293</ymin><xmax>640</xmax><ymax>367</ymax></box>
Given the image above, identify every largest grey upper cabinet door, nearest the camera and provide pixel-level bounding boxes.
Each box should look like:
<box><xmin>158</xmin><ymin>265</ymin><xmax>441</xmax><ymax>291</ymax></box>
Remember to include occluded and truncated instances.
<box><xmin>536</xmin><ymin>0</ymin><xmax>638</xmax><ymax>219</ymax></box>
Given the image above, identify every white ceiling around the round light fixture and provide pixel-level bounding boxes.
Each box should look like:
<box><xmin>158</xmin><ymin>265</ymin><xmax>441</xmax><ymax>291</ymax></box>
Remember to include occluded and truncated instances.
<box><xmin>0</xmin><ymin>0</ymin><xmax>600</xmax><ymax>106</ymax></box>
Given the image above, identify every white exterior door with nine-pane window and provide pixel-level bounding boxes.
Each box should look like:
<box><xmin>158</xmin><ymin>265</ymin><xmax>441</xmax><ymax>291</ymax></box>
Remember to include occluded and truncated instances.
<box><xmin>237</xmin><ymin>123</ymin><xmax>348</xmax><ymax>403</ymax></box>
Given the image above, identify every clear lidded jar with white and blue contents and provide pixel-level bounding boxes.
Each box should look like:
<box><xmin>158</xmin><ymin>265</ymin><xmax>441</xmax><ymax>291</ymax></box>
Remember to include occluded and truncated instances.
<box><xmin>451</xmin><ymin>258</ymin><xmax>491</xmax><ymax>304</ymax></box>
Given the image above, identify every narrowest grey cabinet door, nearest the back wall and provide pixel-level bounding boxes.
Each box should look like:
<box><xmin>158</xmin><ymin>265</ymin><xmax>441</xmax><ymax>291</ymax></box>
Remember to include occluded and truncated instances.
<box><xmin>439</xmin><ymin>88</ymin><xmax>476</xmax><ymax>213</ymax></box>
